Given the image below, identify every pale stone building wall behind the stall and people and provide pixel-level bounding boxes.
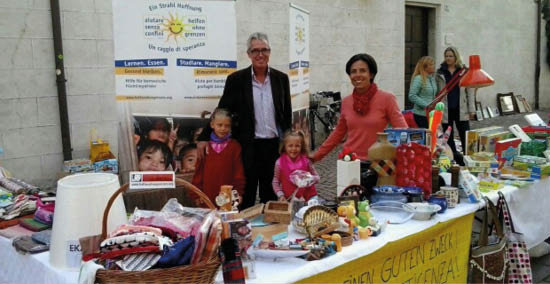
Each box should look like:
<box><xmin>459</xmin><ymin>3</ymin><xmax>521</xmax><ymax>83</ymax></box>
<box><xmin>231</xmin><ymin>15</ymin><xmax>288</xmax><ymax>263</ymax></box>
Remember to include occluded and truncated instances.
<box><xmin>0</xmin><ymin>0</ymin><xmax>550</xmax><ymax>186</ymax></box>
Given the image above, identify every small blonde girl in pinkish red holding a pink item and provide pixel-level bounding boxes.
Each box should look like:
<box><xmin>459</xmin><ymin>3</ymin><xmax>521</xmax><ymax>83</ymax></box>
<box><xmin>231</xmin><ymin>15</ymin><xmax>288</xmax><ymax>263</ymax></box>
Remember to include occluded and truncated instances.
<box><xmin>273</xmin><ymin>131</ymin><xmax>319</xmax><ymax>201</ymax></box>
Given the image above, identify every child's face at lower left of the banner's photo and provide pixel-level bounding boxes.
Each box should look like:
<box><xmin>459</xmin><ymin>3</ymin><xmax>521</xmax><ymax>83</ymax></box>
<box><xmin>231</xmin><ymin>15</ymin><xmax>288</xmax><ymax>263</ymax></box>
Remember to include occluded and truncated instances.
<box><xmin>138</xmin><ymin>139</ymin><xmax>172</xmax><ymax>171</ymax></box>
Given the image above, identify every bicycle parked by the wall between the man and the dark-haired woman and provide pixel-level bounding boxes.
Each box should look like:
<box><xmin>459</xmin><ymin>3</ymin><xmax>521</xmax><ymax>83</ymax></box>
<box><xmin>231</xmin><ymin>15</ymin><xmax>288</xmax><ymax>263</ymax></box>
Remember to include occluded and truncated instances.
<box><xmin>309</xmin><ymin>92</ymin><xmax>342</xmax><ymax>150</ymax></box>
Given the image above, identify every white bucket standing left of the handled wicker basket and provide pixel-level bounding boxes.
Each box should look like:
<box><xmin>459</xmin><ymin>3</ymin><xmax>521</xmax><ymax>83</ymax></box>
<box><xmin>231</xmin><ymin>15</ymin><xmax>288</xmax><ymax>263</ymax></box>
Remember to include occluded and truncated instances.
<box><xmin>50</xmin><ymin>173</ymin><xmax>127</xmax><ymax>270</ymax></box>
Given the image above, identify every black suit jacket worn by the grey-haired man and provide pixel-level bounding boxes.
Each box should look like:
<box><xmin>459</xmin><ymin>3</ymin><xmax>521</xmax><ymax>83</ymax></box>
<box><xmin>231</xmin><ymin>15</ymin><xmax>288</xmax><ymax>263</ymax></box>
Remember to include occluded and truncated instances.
<box><xmin>199</xmin><ymin>66</ymin><xmax>292</xmax><ymax>151</ymax></box>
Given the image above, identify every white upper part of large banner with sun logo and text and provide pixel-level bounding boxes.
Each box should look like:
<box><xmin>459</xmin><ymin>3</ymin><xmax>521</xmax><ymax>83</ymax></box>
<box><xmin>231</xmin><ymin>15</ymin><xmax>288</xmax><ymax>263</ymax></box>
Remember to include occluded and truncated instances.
<box><xmin>113</xmin><ymin>0</ymin><xmax>237</xmax><ymax>117</ymax></box>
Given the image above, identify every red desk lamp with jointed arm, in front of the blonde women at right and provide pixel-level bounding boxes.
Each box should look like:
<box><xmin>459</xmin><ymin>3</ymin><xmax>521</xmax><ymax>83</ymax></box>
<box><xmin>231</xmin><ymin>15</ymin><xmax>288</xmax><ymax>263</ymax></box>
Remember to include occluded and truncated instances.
<box><xmin>426</xmin><ymin>55</ymin><xmax>495</xmax><ymax>118</ymax></box>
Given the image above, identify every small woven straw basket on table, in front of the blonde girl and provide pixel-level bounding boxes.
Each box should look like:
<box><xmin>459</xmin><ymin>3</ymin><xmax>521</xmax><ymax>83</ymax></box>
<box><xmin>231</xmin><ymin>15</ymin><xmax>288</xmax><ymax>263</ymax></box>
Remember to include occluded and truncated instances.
<box><xmin>303</xmin><ymin>205</ymin><xmax>340</xmax><ymax>238</ymax></box>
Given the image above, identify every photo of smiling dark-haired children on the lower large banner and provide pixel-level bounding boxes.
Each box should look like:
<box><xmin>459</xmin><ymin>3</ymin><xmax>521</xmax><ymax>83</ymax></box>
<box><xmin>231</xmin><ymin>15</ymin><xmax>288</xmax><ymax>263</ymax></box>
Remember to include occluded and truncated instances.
<box><xmin>132</xmin><ymin>111</ymin><xmax>210</xmax><ymax>174</ymax></box>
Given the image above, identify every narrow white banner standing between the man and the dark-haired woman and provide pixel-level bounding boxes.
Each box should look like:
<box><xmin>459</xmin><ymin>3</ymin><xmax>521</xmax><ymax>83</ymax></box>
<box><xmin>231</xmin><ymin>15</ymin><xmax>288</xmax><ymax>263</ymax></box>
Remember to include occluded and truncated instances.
<box><xmin>288</xmin><ymin>3</ymin><xmax>310</xmax><ymax>109</ymax></box>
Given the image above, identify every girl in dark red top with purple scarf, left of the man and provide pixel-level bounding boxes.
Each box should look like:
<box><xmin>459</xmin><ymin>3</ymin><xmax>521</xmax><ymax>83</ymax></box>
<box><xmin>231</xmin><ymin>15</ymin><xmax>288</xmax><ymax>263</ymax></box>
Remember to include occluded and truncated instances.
<box><xmin>192</xmin><ymin>108</ymin><xmax>246</xmax><ymax>204</ymax></box>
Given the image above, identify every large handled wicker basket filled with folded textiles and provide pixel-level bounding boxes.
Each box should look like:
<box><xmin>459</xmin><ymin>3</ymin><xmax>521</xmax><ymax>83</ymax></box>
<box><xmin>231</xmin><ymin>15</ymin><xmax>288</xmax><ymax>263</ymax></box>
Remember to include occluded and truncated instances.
<box><xmin>80</xmin><ymin>179</ymin><xmax>222</xmax><ymax>283</ymax></box>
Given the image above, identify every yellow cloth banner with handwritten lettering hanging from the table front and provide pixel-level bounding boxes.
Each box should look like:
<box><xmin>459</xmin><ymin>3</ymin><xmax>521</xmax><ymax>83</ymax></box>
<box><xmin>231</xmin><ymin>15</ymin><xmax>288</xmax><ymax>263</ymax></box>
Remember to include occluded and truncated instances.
<box><xmin>299</xmin><ymin>213</ymin><xmax>474</xmax><ymax>283</ymax></box>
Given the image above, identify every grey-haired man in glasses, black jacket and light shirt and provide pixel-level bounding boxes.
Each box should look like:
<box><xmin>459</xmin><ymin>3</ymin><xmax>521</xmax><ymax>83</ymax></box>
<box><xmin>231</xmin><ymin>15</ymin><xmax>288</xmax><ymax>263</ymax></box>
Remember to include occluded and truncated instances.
<box><xmin>197</xmin><ymin>33</ymin><xmax>292</xmax><ymax>210</ymax></box>
